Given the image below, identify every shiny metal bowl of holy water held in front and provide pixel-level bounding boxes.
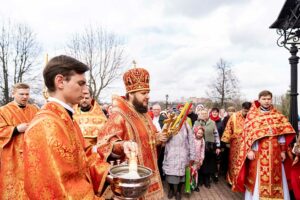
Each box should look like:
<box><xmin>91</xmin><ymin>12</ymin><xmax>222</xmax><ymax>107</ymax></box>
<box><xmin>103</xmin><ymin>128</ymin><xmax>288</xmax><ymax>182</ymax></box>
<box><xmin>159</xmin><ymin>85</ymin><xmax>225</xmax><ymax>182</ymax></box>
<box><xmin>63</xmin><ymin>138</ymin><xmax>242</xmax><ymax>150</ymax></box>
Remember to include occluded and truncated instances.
<box><xmin>107</xmin><ymin>153</ymin><xmax>152</xmax><ymax>200</ymax></box>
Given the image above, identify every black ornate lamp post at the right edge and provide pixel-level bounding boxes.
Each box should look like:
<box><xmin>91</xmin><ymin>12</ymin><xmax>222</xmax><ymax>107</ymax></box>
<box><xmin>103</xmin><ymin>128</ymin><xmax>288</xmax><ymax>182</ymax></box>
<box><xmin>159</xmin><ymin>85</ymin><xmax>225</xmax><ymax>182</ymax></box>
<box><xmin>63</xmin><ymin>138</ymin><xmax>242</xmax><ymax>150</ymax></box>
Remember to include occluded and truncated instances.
<box><xmin>270</xmin><ymin>0</ymin><xmax>300</xmax><ymax>133</ymax></box>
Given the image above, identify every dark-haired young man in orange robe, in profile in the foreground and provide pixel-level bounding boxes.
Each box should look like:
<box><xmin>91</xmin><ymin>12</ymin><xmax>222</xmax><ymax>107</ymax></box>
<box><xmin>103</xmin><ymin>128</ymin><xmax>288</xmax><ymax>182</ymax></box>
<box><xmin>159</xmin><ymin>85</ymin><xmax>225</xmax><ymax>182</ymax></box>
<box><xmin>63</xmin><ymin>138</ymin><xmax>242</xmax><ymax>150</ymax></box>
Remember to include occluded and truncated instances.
<box><xmin>24</xmin><ymin>55</ymin><xmax>133</xmax><ymax>199</ymax></box>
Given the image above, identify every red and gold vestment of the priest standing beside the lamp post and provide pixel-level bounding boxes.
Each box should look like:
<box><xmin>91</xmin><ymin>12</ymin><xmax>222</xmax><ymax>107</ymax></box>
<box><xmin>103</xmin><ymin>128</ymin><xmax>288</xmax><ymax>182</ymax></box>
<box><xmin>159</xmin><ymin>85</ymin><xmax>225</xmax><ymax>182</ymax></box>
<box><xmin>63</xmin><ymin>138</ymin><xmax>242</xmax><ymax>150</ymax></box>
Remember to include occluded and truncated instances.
<box><xmin>234</xmin><ymin>102</ymin><xmax>295</xmax><ymax>199</ymax></box>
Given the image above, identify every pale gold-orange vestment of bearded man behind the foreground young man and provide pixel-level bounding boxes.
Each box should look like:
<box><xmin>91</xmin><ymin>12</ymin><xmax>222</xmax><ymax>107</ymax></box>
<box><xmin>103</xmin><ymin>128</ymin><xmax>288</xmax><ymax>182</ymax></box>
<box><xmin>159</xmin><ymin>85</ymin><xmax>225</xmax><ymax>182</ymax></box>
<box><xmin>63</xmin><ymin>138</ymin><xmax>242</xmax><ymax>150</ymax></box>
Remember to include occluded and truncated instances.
<box><xmin>73</xmin><ymin>101</ymin><xmax>107</xmax><ymax>147</ymax></box>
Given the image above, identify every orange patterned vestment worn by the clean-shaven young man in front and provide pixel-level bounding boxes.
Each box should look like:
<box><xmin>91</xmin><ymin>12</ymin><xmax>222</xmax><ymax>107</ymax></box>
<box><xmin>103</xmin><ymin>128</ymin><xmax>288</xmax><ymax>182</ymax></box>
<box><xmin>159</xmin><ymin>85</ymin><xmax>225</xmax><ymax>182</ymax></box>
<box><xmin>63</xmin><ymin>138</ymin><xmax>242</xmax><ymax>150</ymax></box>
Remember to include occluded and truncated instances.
<box><xmin>24</xmin><ymin>102</ymin><xmax>104</xmax><ymax>199</ymax></box>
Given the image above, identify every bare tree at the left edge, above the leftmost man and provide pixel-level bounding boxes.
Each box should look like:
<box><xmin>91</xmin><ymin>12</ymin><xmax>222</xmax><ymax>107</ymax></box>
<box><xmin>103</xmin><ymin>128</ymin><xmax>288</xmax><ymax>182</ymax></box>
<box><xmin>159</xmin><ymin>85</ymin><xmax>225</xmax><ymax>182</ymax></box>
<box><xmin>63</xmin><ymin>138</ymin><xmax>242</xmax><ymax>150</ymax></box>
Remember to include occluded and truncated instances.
<box><xmin>0</xmin><ymin>20</ymin><xmax>41</xmax><ymax>104</ymax></box>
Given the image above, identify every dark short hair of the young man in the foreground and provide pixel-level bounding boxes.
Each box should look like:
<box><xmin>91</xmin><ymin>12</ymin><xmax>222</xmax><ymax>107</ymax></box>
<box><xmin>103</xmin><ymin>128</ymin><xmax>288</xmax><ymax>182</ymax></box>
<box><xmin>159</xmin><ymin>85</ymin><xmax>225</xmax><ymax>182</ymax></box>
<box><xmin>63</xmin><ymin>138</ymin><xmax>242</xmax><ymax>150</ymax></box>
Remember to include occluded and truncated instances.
<box><xmin>43</xmin><ymin>55</ymin><xmax>89</xmax><ymax>92</ymax></box>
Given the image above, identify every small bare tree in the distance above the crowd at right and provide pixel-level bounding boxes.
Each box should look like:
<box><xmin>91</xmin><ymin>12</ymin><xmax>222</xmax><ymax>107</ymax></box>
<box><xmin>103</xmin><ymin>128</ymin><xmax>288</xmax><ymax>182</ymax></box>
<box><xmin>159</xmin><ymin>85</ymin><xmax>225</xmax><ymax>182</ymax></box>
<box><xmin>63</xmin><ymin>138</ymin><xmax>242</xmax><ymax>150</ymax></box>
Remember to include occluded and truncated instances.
<box><xmin>206</xmin><ymin>58</ymin><xmax>239</xmax><ymax>107</ymax></box>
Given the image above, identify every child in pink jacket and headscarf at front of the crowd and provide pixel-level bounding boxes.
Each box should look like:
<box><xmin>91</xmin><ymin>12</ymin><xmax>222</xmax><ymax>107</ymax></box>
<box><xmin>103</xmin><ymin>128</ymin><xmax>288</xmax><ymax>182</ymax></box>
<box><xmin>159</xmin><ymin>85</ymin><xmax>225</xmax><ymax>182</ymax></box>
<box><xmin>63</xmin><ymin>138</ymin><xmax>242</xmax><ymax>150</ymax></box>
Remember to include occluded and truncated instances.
<box><xmin>193</xmin><ymin>125</ymin><xmax>205</xmax><ymax>192</ymax></box>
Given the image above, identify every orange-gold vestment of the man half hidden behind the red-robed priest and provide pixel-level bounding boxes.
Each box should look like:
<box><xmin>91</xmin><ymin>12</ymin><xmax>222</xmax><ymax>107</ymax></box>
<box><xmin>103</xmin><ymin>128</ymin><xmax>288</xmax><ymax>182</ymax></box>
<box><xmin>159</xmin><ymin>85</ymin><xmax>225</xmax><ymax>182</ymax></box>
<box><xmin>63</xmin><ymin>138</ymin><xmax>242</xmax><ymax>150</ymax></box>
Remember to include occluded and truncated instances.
<box><xmin>221</xmin><ymin>111</ymin><xmax>245</xmax><ymax>187</ymax></box>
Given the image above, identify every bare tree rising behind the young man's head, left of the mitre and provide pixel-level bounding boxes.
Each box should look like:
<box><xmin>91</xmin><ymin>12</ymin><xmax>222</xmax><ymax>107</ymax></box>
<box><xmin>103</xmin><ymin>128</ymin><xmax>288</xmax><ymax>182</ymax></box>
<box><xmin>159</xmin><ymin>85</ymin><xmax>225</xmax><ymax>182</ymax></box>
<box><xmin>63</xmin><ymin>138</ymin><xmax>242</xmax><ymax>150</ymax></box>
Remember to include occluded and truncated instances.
<box><xmin>67</xmin><ymin>26</ymin><xmax>124</xmax><ymax>99</ymax></box>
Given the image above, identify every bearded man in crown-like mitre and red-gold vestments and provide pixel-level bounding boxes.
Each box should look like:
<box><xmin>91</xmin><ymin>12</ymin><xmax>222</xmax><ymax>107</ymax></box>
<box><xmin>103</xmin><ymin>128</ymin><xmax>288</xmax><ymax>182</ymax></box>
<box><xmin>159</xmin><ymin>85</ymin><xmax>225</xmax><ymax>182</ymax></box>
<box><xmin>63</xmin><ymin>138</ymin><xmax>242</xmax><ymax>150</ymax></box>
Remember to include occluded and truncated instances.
<box><xmin>98</xmin><ymin>65</ymin><xmax>167</xmax><ymax>200</ymax></box>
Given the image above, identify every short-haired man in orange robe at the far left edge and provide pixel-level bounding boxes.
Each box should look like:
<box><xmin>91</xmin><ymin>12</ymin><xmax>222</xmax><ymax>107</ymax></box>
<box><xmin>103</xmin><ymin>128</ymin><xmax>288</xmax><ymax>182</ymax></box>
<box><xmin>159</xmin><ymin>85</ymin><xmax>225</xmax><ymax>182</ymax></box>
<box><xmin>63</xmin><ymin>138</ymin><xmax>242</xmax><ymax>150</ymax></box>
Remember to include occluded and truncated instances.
<box><xmin>0</xmin><ymin>83</ymin><xmax>38</xmax><ymax>199</ymax></box>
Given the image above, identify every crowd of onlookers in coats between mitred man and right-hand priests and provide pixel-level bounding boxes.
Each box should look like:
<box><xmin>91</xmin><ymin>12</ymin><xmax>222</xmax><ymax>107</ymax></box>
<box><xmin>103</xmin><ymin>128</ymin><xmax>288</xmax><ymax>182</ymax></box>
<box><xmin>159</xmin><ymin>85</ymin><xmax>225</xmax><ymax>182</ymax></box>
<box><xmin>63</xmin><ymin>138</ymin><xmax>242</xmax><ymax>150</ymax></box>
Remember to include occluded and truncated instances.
<box><xmin>150</xmin><ymin>102</ymin><xmax>246</xmax><ymax>199</ymax></box>
